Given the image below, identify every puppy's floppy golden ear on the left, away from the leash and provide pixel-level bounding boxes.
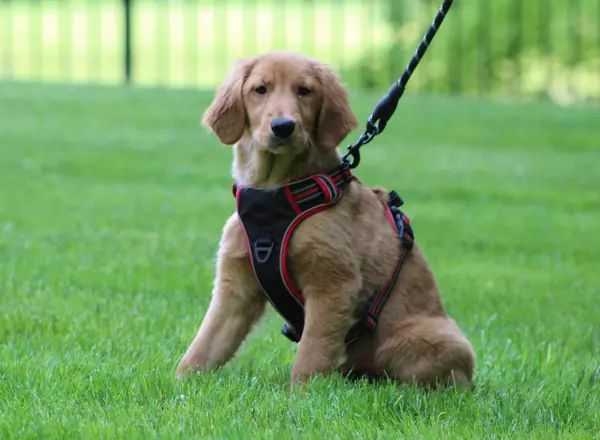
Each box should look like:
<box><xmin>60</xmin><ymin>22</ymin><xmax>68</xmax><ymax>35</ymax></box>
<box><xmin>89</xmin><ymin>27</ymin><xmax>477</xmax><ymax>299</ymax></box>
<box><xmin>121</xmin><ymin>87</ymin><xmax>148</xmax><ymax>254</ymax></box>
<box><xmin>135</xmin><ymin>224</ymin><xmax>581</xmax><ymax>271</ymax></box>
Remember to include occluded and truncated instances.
<box><xmin>202</xmin><ymin>59</ymin><xmax>255</xmax><ymax>145</ymax></box>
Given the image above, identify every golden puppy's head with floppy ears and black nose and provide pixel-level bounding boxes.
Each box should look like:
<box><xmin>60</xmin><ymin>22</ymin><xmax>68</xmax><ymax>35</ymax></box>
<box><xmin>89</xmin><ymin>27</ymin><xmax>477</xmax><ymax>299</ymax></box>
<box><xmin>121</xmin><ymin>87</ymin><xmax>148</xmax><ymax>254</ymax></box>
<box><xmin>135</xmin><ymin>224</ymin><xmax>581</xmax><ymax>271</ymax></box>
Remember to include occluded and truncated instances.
<box><xmin>203</xmin><ymin>52</ymin><xmax>358</xmax><ymax>154</ymax></box>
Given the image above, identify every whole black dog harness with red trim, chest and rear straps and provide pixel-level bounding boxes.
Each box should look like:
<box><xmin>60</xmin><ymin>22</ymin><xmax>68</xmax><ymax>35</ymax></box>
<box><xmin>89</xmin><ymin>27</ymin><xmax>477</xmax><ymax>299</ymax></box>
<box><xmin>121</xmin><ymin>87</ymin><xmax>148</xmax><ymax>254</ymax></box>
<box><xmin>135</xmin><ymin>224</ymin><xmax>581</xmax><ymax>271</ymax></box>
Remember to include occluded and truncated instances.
<box><xmin>233</xmin><ymin>167</ymin><xmax>414</xmax><ymax>344</ymax></box>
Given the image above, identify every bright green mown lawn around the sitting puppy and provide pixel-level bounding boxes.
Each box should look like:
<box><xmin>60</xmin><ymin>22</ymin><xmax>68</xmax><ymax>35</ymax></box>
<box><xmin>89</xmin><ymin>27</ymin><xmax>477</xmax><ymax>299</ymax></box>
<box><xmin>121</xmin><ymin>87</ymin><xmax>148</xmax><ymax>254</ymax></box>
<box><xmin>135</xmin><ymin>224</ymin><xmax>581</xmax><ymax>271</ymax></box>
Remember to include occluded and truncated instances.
<box><xmin>0</xmin><ymin>83</ymin><xmax>600</xmax><ymax>439</ymax></box>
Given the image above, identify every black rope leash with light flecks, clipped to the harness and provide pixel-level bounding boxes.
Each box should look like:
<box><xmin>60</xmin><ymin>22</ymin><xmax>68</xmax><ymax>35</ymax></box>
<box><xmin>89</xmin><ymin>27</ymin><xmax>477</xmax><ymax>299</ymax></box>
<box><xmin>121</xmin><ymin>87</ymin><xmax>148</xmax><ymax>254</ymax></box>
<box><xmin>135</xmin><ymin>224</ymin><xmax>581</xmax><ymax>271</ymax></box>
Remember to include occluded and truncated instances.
<box><xmin>342</xmin><ymin>0</ymin><xmax>453</xmax><ymax>168</ymax></box>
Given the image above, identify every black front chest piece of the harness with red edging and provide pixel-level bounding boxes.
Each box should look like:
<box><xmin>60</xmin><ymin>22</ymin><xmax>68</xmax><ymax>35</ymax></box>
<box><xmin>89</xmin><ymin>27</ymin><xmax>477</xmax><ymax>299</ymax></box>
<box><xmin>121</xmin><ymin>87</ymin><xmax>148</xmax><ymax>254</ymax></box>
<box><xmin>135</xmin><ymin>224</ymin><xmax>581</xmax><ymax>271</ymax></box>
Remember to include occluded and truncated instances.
<box><xmin>232</xmin><ymin>167</ymin><xmax>354</xmax><ymax>340</ymax></box>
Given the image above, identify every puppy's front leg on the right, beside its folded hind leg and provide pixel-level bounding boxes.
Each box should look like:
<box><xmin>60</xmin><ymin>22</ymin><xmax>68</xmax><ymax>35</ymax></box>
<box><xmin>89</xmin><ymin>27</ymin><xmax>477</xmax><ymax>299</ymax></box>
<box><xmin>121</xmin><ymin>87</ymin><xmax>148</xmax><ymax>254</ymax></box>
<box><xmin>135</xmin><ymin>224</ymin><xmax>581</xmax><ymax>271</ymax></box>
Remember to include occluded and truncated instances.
<box><xmin>291</xmin><ymin>282</ymin><xmax>358</xmax><ymax>390</ymax></box>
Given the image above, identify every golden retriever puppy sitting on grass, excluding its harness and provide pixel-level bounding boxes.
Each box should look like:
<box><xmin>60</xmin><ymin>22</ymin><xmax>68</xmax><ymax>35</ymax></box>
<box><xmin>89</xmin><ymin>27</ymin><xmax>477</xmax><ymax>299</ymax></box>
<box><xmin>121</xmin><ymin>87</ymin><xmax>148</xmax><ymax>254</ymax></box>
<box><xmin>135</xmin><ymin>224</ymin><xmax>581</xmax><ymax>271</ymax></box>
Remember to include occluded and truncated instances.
<box><xmin>177</xmin><ymin>52</ymin><xmax>475</xmax><ymax>389</ymax></box>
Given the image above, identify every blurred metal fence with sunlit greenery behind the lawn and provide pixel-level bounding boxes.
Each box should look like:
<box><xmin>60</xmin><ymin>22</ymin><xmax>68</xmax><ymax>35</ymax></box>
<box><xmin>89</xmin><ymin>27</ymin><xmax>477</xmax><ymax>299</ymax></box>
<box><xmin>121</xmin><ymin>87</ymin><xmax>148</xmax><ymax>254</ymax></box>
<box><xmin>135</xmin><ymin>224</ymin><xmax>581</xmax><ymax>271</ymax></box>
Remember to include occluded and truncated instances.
<box><xmin>0</xmin><ymin>0</ymin><xmax>600</xmax><ymax>102</ymax></box>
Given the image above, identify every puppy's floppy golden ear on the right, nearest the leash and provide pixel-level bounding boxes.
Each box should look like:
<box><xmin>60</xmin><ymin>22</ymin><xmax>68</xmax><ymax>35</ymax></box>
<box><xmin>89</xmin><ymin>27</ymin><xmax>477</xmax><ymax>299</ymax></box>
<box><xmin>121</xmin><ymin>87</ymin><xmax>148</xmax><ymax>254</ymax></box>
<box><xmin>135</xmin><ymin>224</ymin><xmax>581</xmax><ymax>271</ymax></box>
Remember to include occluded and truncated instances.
<box><xmin>317</xmin><ymin>64</ymin><xmax>358</xmax><ymax>149</ymax></box>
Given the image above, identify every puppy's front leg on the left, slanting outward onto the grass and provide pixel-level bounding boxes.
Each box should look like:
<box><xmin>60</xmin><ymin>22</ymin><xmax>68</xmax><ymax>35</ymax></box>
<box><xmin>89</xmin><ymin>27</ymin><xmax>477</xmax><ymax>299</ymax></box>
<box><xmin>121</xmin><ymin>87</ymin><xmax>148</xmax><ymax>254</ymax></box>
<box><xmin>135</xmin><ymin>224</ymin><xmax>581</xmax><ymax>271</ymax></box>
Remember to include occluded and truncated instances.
<box><xmin>177</xmin><ymin>258</ymin><xmax>266</xmax><ymax>378</ymax></box>
